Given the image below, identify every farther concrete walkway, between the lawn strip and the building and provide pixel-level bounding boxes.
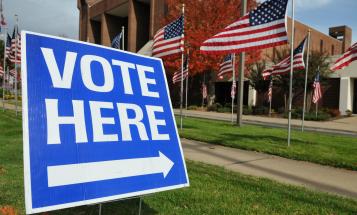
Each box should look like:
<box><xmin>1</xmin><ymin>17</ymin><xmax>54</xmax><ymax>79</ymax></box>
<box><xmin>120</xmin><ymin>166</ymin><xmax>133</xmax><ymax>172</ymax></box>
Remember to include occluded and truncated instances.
<box><xmin>174</xmin><ymin>109</ymin><xmax>357</xmax><ymax>136</ymax></box>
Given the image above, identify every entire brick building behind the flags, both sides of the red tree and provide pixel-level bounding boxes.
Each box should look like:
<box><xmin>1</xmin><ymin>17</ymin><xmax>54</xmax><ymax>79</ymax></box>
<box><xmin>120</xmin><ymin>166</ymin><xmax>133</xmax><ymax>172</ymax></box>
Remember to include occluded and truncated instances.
<box><xmin>77</xmin><ymin>0</ymin><xmax>357</xmax><ymax>113</ymax></box>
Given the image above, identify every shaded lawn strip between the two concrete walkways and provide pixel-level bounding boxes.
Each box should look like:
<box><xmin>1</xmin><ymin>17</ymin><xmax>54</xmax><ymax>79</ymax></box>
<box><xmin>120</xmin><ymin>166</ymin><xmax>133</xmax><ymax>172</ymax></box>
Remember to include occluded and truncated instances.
<box><xmin>180</xmin><ymin>118</ymin><xmax>357</xmax><ymax>170</ymax></box>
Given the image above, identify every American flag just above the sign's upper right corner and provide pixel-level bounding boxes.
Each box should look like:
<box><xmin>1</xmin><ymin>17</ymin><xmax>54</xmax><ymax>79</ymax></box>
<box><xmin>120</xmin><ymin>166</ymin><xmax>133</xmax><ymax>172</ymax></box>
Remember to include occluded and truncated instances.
<box><xmin>152</xmin><ymin>16</ymin><xmax>184</xmax><ymax>57</ymax></box>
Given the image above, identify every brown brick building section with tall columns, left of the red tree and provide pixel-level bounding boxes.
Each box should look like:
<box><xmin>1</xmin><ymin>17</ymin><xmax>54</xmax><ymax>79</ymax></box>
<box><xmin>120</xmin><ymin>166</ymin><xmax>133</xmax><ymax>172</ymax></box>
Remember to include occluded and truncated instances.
<box><xmin>78</xmin><ymin>0</ymin><xmax>165</xmax><ymax>52</ymax></box>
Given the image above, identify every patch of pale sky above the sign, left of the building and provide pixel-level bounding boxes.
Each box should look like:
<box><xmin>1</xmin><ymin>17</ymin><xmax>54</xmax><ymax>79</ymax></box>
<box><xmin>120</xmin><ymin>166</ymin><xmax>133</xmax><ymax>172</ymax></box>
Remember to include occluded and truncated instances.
<box><xmin>2</xmin><ymin>0</ymin><xmax>79</xmax><ymax>39</ymax></box>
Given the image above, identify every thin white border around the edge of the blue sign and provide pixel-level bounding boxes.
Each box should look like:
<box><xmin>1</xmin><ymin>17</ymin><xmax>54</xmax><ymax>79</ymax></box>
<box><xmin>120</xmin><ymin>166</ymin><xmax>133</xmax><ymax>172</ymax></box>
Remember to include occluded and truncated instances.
<box><xmin>21</xmin><ymin>31</ymin><xmax>190</xmax><ymax>214</ymax></box>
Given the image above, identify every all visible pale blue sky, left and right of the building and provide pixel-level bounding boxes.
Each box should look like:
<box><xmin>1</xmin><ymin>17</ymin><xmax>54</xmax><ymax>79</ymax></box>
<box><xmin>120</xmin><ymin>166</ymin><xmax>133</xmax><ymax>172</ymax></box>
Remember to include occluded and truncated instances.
<box><xmin>3</xmin><ymin>0</ymin><xmax>357</xmax><ymax>42</ymax></box>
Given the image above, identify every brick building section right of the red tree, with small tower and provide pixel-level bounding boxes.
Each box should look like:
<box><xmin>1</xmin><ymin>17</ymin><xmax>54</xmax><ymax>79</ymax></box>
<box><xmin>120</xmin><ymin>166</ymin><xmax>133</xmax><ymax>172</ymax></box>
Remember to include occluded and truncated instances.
<box><xmin>251</xmin><ymin>18</ymin><xmax>357</xmax><ymax>113</ymax></box>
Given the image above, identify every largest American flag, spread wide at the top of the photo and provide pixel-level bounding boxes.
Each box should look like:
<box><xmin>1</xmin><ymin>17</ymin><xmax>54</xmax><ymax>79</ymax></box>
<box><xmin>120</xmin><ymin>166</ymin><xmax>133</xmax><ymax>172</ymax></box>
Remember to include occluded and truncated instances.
<box><xmin>201</xmin><ymin>0</ymin><xmax>288</xmax><ymax>54</ymax></box>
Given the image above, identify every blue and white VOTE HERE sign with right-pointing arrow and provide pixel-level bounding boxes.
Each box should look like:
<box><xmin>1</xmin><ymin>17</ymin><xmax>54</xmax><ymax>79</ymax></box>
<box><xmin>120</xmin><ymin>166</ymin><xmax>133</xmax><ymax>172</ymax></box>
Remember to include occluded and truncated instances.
<box><xmin>21</xmin><ymin>32</ymin><xmax>189</xmax><ymax>214</ymax></box>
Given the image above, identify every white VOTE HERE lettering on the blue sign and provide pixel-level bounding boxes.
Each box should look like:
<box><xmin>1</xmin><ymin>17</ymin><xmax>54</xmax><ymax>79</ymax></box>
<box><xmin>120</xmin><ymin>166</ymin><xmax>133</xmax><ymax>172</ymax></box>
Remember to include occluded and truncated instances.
<box><xmin>41</xmin><ymin>48</ymin><xmax>170</xmax><ymax>144</ymax></box>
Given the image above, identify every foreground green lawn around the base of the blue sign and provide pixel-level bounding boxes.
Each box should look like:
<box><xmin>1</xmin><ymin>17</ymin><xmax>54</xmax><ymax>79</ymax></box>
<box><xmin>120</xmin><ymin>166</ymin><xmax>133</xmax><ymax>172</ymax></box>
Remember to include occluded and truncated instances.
<box><xmin>0</xmin><ymin>110</ymin><xmax>357</xmax><ymax>215</ymax></box>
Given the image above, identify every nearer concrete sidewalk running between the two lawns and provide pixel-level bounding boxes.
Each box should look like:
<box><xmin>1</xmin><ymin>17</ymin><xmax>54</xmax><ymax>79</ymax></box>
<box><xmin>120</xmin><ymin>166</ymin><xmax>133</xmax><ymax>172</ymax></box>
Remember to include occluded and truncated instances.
<box><xmin>181</xmin><ymin>139</ymin><xmax>357</xmax><ymax>199</ymax></box>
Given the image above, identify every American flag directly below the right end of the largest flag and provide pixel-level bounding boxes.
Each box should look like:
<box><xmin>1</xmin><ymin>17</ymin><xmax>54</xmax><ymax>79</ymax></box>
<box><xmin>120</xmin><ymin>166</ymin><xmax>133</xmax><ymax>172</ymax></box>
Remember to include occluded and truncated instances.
<box><xmin>263</xmin><ymin>38</ymin><xmax>307</xmax><ymax>80</ymax></box>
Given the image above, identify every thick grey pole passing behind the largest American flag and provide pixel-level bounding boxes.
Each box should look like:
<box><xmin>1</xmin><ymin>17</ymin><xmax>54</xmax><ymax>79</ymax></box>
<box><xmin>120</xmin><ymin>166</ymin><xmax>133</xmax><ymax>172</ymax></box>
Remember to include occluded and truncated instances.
<box><xmin>237</xmin><ymin>0</ymin><xmax>247</xmax><ymax>126</ymax></box>
